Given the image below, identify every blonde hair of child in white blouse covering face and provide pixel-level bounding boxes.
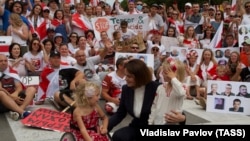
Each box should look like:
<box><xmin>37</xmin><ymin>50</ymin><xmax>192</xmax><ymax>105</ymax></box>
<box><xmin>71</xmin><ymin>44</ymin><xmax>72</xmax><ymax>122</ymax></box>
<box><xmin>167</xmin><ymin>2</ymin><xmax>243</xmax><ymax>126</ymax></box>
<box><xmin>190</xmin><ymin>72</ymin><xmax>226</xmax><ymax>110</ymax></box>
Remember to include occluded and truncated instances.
<box><xmin>162</xmin><ymin>59</ymin><xmax>186</xmax><ymax>82</ymax></box>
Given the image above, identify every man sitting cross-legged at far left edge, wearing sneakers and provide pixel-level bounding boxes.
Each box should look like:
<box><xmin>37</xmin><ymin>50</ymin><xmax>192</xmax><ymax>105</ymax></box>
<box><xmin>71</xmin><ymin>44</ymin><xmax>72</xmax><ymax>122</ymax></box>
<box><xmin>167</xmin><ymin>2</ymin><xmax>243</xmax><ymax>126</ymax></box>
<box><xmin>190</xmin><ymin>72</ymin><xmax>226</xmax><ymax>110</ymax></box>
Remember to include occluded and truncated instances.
<box><xmin>0</xmin><ymin>54</ymin><xmax>36</xmax><ymax>120</ymax></box>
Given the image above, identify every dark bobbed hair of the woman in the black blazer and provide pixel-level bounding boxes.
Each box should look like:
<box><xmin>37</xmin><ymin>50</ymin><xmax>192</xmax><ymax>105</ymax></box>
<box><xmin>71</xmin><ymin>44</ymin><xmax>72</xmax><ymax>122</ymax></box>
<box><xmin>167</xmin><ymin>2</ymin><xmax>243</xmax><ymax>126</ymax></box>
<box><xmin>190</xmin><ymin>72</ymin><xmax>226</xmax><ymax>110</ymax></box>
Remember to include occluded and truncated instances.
<box><xmin>125</xmin><ymin>59</ymin><xmax>152</xmax><ymax>88</ymax></box>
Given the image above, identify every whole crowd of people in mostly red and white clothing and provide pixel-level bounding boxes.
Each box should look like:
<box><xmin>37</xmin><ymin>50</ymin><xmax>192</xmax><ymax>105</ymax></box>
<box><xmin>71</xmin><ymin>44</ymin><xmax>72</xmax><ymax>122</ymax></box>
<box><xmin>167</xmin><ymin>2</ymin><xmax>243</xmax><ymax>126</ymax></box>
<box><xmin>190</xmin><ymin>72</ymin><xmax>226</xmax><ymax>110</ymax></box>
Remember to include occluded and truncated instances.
<box><xmin>0</xmin><ymin>0</ymin><xmax>250</xmax><ymax>141</ymax></box>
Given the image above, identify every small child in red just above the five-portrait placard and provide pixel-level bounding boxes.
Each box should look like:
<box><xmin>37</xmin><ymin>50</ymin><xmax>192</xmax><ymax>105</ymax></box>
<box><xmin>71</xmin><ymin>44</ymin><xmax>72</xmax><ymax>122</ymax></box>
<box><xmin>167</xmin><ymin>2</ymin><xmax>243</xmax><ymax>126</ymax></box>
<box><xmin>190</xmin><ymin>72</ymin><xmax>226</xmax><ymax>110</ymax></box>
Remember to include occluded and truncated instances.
<box><xmin>213</xmin><ymin>65</ymin><xmax>230</xmax><ymax>81</ymax></box>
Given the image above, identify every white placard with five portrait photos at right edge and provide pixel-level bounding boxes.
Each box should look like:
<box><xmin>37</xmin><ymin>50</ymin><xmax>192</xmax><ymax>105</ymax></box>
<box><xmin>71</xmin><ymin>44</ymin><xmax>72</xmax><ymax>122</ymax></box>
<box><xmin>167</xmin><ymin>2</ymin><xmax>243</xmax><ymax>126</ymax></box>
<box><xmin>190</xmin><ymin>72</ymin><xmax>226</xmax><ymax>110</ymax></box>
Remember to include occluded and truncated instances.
<box><xmin>206</xmin><ymin>80</ymin><xmax>250</xmax><ymax>115</ymax></box>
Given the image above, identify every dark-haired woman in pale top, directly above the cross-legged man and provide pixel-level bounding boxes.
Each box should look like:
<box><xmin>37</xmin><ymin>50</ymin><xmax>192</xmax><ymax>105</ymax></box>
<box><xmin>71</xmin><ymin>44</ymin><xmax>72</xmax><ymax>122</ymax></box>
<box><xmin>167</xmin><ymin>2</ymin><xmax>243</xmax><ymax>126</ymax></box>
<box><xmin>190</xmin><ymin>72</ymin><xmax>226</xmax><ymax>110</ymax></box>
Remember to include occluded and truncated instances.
<box><xmin>9</xmin><ymin>43</ymin><xmax>28</xmax><ymax>77</ymax></box>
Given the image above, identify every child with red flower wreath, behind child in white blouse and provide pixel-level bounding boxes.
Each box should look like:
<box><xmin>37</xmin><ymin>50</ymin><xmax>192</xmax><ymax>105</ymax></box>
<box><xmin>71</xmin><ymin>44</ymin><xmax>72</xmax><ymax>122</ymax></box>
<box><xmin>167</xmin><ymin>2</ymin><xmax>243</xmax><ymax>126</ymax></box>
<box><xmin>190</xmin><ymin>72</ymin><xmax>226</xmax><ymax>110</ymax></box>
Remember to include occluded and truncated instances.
<box><xmin>185</xmin><ymin>50</ymin><xmax>201</xmax><ymax>100</ymax></box>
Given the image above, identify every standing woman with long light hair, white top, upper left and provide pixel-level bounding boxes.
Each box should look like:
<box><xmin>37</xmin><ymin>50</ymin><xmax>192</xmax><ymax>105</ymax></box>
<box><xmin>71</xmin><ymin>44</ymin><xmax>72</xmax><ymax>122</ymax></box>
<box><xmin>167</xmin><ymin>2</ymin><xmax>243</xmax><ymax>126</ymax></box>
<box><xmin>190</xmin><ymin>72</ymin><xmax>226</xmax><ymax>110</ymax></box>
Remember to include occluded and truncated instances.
<box><xmin>7</xmin><ymin>13</ymin><xmax>29</xmax><ymax>55</ymax></box>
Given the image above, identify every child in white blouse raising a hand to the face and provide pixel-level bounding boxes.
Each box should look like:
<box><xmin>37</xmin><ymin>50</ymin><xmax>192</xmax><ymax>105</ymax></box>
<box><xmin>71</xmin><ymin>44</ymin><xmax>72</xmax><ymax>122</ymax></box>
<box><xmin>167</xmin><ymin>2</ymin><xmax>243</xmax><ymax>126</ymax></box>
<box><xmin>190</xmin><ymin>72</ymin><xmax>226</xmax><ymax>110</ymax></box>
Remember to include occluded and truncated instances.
<box><xmin>148</xmin><ymin>58</ymin><xmax>186</xmax><ymax>125</ymax></box>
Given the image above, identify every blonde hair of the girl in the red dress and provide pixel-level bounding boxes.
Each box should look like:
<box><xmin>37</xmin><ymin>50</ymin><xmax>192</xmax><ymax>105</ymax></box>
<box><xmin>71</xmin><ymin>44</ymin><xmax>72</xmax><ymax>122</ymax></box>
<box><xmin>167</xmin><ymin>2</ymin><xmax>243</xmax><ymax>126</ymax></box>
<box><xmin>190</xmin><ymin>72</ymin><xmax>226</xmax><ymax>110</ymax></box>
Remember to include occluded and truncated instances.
<box><xmin>73</xmin><ymin>82</ymin><xmax>100</xmax><ymax>106</ymax></box>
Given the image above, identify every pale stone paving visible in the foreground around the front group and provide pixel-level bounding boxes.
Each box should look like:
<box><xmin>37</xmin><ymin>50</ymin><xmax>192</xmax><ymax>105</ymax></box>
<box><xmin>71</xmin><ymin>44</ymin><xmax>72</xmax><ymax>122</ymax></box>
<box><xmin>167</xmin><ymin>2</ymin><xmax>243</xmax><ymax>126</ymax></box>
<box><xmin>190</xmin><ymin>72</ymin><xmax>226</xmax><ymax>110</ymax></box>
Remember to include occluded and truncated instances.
<box><xmin>0</xmin><ymin>100</ymin><xmax>250</xmax><ymax>141</ymax></box>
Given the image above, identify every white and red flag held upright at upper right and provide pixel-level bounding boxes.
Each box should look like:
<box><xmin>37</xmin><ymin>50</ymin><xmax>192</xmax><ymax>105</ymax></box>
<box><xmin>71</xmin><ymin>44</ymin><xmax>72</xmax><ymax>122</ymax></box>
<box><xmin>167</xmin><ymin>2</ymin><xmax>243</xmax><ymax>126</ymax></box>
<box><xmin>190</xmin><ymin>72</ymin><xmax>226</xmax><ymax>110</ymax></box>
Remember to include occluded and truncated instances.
<box><xmin>208</xmin><ymin>21</ymin><xmax>224</xmax><ymax>48</ymax></box>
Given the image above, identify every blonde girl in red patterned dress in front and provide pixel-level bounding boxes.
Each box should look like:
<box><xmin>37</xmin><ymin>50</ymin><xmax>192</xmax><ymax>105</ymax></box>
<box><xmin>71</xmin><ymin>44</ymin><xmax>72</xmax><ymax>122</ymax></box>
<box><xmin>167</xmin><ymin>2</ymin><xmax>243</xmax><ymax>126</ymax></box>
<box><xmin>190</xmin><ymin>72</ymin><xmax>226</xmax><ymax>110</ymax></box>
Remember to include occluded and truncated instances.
<box><xmin>71</xmin><ymin>82</ymin><xmax>109</xmax><ymax>141</ymax></box>
